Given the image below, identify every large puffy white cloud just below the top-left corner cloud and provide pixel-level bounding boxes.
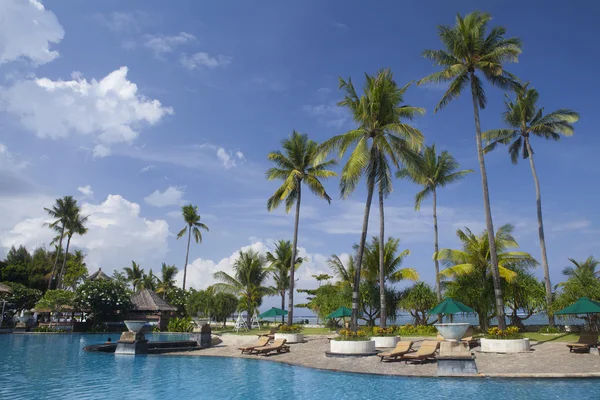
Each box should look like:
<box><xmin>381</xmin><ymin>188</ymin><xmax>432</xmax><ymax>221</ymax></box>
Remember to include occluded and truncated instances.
<box><xmin>0</xmin><ymin>67</ymin><xmax>173</xmax><ymax>157</ymax></box>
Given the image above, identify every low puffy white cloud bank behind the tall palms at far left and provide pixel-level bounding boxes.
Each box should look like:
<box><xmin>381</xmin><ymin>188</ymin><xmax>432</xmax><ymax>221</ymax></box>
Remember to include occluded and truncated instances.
<box><xmin>0</xmin><ymin>195</ymin><xmax>169</xmax><ymax>273</ymax></box>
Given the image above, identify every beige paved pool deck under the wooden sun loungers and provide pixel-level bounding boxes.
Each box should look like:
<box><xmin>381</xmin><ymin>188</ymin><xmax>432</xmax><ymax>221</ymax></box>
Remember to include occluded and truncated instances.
<box><xmin>173</xmin><ymin>334</ymin><xmax>600</xmax><ymax>378</ymax></box>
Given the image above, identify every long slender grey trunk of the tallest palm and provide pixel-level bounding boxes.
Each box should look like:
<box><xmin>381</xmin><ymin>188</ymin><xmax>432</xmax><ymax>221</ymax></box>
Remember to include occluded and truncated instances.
<box><xmin>471</xmin><ymin>72</ymin><xmax>506</xmax><ymax>329</ymax></box>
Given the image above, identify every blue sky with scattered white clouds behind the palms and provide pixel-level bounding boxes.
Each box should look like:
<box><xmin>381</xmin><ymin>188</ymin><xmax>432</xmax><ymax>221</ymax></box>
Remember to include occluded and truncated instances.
<box><xmin>0</xmin><ymin>0</ymin><xmax>600</xmax><ymax>307</ymax></box>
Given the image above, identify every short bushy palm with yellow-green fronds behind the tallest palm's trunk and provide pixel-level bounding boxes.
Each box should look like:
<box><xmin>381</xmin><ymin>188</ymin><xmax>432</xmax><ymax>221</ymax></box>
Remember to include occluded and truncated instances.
<box><xmin>434</xmin><ymin>224</ymin><xmax>537</xmax><ymax>330</ymax></box>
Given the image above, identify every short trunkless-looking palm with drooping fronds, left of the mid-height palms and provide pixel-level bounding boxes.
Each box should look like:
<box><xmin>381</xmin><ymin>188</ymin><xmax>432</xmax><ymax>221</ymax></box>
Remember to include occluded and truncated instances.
<box><xmin>213</xmin><ymin>250</ymin><xmax>277</xmax><ymax>327</ymax></box>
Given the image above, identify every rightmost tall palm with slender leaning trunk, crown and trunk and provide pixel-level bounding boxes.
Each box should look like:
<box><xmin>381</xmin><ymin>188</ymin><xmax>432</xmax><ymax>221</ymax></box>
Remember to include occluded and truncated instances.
<box><xmin>483</xmin><ymin>83</ymin><xmax>579</xmax><ymax>326</ymax></box>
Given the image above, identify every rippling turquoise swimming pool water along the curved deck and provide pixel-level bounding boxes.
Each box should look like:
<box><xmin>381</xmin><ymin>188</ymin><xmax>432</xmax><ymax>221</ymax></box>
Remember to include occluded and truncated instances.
<box><xmin>0</xmin><ymin>334</ymin><xmax>600</xmax><ymax>400</ymax></box>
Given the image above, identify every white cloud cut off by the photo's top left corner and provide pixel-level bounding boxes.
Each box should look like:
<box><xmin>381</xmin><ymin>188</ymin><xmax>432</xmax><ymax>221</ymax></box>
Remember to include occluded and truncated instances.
<box><xmin>0</xmin><ymin>0</ymin><xmax>65</xmax><ymax>65</ymax></box>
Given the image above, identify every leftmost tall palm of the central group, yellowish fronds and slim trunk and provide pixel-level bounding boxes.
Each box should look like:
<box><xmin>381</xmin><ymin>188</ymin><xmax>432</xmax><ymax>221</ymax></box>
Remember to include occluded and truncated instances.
<box><xmin>267</xmin><ymin>131</ymin><xmax>337</xmax><ymax>325</ymax></box>
